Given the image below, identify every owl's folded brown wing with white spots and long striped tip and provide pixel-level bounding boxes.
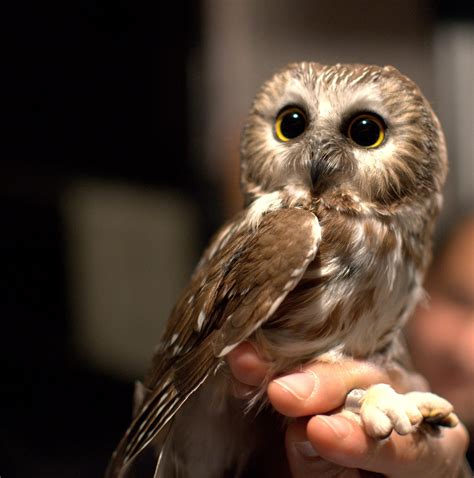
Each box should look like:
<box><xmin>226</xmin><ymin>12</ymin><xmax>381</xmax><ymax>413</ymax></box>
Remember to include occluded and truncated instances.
<box><xmin>106</xmin><ymin>208</ymin><xmax>321</xmax><ymax>477</ymax></box>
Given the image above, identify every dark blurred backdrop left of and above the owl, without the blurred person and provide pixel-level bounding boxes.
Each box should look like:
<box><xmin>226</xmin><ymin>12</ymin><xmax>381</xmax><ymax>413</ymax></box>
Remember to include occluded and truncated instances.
<box><xmin>0</xmin><ymin>0</ymin><xmax>474</xmax><ymax>478</ymax></box>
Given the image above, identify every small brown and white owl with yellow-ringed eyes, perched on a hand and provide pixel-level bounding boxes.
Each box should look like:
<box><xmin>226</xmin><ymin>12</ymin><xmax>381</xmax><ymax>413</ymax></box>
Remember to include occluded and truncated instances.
<box><xmin>106</xmin><ymin>62</ymin><xmax>456</xmax><ymax>478</ymax></box>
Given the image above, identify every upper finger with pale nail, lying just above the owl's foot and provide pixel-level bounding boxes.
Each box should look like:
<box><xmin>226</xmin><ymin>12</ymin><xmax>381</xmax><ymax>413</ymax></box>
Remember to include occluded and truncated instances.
<box><xmin>268</xmin><ymin>360</ymin><xmax>391</xmax><ymax>417</ymax></box>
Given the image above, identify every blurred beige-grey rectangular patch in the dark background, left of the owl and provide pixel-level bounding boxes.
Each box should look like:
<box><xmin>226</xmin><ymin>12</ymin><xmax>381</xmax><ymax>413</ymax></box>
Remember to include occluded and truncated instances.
<box><xmin>63</xmin><ymin>180</ymin><xmax>199</xmax><ymax>380</ymax></box>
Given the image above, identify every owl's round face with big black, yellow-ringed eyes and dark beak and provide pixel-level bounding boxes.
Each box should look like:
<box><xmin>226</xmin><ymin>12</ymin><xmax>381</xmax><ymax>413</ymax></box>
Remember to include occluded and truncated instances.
<box><xmin>241</xmin><ymin>63</ymin><xmax>446</xmax><ymax>205</ymax></box>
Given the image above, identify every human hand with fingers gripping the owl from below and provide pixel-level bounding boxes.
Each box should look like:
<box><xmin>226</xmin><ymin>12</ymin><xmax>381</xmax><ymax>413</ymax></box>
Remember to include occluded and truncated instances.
<box><xmin>228</xmin><ymin>342</ymin><xmax>468</xmax><ymax>478</ymax></box>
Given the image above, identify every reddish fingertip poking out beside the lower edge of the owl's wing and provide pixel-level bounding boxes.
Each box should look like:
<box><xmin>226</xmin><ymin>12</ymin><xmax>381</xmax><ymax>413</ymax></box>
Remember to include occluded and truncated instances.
<box><xmin>227</xmin><ymin>342</ymin><xmax>269</xmax><ymax>387</ymax></box>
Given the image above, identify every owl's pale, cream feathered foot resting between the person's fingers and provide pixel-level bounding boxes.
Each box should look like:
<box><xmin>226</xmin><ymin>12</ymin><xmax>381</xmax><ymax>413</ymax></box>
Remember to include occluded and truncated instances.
<box><xmin>344</xmin><ymin>383</ymin><xmax>458</xmax><ymax>439</ymax></box>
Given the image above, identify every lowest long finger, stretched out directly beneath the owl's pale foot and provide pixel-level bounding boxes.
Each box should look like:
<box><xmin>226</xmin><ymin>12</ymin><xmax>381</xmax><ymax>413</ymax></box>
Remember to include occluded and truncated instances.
<box><xmin>306</xmin><ymin>414</ymin><xmax>468</xmax><ymax>478</ymax></box>
